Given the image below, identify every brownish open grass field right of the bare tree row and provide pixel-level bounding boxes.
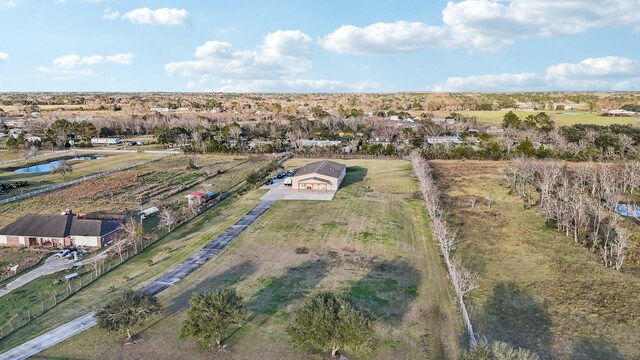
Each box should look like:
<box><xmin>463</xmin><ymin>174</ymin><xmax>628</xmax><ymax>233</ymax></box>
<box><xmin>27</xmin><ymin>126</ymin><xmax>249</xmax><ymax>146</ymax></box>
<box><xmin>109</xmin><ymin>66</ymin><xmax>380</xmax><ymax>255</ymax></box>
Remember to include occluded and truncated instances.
<box><xmin>433</xmin><ymin>161</ymin><xmax>640</xmax><ymax>359</ymax></box>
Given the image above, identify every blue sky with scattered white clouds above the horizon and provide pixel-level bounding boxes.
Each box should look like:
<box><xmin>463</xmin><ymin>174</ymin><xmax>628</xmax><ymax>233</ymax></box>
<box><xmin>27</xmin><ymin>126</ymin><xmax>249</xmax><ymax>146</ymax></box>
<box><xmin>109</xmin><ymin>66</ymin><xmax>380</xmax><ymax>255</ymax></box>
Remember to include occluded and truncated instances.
<box><xmin>0</xmin><ymin>0</ymin><xmax>640</xmax><ymax>93</ymax></box>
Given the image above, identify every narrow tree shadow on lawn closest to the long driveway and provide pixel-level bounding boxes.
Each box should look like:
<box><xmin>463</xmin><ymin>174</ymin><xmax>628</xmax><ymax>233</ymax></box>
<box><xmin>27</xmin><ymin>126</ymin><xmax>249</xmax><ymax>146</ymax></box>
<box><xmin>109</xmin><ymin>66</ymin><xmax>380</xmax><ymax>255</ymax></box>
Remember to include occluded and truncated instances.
<box><xmin>165</xmin><ymin>261</ymin><xmax>256</xmax><ymax>316</ymax></box>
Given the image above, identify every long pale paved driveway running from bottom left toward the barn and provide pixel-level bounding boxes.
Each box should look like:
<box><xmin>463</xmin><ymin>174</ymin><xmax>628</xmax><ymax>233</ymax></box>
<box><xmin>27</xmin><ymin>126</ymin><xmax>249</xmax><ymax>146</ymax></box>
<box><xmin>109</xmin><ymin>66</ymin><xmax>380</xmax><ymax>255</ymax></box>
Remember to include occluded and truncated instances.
<box><xmin>0</xmin><ymin>201</ymin><xmax>273</xmax><ymax>360</ymax></box>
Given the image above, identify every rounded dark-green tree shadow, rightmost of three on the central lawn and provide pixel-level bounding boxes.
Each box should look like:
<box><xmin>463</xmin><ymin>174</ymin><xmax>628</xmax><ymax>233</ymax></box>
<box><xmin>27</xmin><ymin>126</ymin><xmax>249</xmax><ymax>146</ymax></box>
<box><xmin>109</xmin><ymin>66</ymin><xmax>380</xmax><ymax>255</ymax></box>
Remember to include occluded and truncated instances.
<box><xmin>347</xmin><ymin>260</ymin><xmax>420</xmax><ymax>326</ymax></box>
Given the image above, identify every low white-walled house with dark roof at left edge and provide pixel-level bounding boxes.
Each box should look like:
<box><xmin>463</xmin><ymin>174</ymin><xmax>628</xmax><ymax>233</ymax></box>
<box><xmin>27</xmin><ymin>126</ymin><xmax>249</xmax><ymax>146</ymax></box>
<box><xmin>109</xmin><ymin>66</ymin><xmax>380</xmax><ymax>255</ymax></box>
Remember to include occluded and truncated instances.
<box><xmin>0</xmin><ymin>214</ymin><xmax>122</xmax><ymax>248</ymax></box>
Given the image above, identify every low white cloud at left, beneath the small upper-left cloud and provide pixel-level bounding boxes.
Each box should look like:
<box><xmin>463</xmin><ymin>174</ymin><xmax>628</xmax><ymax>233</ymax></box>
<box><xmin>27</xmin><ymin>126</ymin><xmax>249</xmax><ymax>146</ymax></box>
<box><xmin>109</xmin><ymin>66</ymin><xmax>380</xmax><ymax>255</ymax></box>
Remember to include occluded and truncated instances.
<box><xmin>36</xmin><ymin>53</ymin><xmax>135</xmax><ymax>80</ymax></box>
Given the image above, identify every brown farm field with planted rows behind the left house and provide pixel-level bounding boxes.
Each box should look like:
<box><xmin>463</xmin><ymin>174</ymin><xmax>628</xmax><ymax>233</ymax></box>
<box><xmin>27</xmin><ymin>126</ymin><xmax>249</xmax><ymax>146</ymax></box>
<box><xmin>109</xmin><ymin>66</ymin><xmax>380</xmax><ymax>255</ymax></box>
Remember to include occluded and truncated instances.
<box><xmin>0</xmin><ymin>155</ymin><xmax>265</xmax><ymax>227</ymax></box>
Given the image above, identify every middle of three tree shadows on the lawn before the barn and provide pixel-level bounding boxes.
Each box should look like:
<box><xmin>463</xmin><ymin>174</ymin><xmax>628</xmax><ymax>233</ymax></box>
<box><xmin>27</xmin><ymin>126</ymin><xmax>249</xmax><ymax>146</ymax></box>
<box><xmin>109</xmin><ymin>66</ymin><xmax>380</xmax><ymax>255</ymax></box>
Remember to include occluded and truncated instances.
<box><xmin>247</xmin><ymin>259</ymin><xmax>329</xmax><ymax>325</ymax></box>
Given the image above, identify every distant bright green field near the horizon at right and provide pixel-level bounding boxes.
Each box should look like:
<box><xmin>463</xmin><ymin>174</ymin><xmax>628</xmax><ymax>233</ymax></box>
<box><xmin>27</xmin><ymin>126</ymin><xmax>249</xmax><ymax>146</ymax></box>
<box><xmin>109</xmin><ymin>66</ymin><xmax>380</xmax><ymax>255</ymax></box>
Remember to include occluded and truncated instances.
<box><xmin>436</xmin><ymin>110</ymin><xmax>640</xmax><ymax>126</ymax></box>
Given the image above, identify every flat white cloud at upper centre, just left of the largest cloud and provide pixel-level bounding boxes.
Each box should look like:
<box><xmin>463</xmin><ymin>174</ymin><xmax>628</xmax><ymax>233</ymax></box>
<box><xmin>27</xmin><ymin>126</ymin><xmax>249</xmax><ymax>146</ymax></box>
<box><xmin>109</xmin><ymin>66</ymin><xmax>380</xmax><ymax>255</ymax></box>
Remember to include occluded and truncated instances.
<box><xmin>320</xmin><ymin>21</ymin><xmax>447</xmax><ymax>54</ymax></box>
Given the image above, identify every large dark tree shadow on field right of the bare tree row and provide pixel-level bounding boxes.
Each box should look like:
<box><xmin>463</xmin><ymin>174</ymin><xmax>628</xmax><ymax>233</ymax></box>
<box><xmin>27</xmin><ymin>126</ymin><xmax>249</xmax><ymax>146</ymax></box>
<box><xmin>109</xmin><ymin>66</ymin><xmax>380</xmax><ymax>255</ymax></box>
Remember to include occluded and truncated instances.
<box><xmin>478</xmin><ymin>282</ymin><xmax>553</xmax><ymax>358</ymax></box>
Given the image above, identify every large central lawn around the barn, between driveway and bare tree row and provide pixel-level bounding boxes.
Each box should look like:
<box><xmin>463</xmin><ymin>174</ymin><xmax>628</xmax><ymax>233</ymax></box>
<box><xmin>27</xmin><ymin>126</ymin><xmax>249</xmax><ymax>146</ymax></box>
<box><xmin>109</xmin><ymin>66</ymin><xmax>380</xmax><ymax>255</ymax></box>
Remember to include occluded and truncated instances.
<box><xmin>37</xmin><ymin>159</ymin><xmax>463</xmax><ymax>359</ymax></box>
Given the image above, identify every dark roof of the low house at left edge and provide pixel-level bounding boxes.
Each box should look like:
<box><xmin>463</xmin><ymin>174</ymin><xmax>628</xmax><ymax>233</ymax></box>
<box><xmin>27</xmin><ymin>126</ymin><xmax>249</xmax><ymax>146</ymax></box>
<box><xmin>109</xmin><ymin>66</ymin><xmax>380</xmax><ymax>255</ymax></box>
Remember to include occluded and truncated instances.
<box><xmin>0</xmin><ymin>214</ymin><xmax>118</xmax><ymax>238</ymax></box>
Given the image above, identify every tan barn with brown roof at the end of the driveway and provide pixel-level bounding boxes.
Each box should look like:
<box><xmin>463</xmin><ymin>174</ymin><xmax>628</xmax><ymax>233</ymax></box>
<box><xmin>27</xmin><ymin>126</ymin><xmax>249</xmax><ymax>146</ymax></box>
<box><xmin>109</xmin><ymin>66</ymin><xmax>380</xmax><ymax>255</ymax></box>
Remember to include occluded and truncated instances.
<box><xmin>291</xmin><ymin>160</ymin><xmax>347</xmax><ymax>191</ymax></box>
